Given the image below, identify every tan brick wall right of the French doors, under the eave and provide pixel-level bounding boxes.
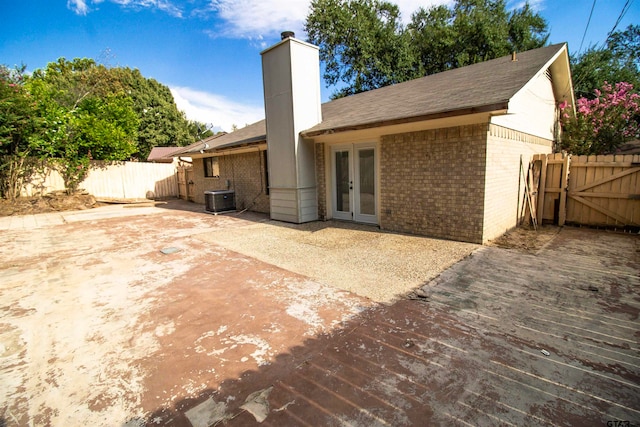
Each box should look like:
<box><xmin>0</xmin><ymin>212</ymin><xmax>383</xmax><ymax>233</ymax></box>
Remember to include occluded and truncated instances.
<box><xmin>380</xmin><ymin>124</ymin><xmax>488</xmax><ymax>243</ymax></box>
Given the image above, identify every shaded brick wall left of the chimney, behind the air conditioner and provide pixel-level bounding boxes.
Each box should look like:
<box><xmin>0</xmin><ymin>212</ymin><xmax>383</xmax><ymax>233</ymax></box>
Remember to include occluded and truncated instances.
<box><xmin>193</xmin><ymin>151</ymin><xmax>269</xmax><ymax>213</ymax></box>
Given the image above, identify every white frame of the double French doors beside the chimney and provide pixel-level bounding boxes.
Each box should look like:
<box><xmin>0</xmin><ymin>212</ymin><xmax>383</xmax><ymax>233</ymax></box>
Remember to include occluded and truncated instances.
<box><xmin>330</xmin><ymin>142</ymin><xmax>378</xmax><ymax>224</ymax></box>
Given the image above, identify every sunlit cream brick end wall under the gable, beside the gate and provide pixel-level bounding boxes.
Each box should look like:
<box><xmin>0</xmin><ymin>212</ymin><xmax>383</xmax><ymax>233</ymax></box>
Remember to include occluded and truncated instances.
<box><xmin>482</xmin><ymin>124</ymin><xmax>553</xmax><ymax>243</ymax></box>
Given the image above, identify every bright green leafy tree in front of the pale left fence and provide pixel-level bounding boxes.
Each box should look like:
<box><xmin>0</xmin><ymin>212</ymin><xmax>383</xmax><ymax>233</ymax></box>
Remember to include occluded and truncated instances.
<box><xmin>26</xmin><ymin>59</ymin><xmax>139</xmax><ymax>192</ymax></box>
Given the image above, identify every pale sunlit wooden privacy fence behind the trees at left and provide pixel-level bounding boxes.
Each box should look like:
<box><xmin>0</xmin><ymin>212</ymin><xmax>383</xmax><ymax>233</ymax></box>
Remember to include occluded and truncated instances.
<box><xmin>21</xmin><ymin>161</ymin><xmax>178</xmax><ymax>199</ymax></box>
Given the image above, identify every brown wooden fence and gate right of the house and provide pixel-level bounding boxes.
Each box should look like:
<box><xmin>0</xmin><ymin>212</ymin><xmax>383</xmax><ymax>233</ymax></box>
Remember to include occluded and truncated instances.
<box><xmin>528</xmin><ymin>153</ymin><xmax>640</xmax><ymax>228</ymax></box>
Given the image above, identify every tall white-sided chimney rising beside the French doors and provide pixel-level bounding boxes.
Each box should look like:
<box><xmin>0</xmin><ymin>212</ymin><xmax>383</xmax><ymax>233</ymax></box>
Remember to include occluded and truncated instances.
<box><xmin>261</xmin><ymin>31</ymin><xmax>322</xmax><ymax>223</ymax></box>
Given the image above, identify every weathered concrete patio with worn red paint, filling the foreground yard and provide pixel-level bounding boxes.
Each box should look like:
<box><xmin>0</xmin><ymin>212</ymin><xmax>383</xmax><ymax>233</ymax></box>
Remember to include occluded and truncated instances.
<box><xmin>0</xmin><ymin>201</ymin><xmax>640</xmax><ymax>426</ymax></box>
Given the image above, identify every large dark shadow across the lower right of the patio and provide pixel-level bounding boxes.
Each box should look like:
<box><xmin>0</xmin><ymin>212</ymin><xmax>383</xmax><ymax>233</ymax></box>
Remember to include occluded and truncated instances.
<box><xmin>123</xmin><ymin>202</ymin><xmax>640</xmax><ymax>426</ymax></box>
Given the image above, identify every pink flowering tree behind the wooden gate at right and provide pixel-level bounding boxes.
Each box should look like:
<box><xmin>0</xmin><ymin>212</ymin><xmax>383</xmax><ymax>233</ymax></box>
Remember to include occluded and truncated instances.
<box><xmin>559</xmin><ymin>82</ymin><xmax>640</xmax><ymax>154</ymax></box>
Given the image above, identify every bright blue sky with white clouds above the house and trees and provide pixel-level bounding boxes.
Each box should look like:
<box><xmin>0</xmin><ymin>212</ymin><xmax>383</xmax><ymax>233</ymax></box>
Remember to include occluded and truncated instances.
<box><xmin>0</xmin><ymin>0</ymin><xmax>640</xmax><ymax>131</ymax></box>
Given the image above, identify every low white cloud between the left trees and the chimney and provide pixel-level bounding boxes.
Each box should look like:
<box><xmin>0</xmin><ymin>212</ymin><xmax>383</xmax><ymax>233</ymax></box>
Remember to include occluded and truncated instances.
<box><xmin>170</xmin><ymin>86</ymin><xmax>264</xmax><ymax>132</ymax></box>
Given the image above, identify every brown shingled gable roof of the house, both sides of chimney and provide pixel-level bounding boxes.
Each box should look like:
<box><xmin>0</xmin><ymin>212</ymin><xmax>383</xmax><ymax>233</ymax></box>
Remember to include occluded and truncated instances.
<box><xmin>175</xmin><ymin>43</ymin><xmax>573</xmax><ymax>153</ymax></box>
